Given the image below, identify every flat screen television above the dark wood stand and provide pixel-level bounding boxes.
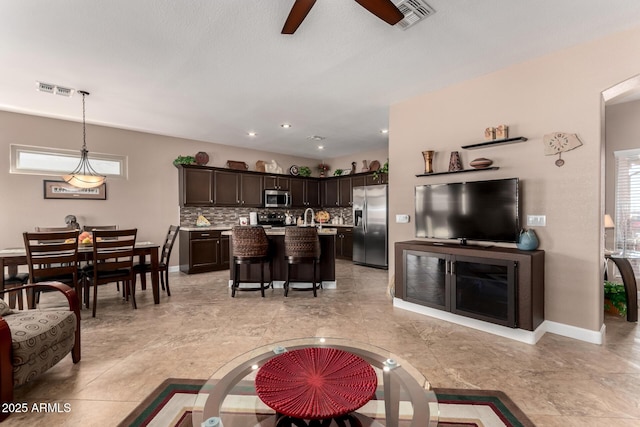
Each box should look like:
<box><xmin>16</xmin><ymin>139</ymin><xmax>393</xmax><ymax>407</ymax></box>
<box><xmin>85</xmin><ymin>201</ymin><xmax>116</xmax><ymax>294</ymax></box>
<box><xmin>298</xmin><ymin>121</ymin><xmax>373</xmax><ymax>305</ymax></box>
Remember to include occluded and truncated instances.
<box><xmin>415</xmin><ymin>178</ymin><xmax>520</xmax><ymax>244</ymax></box>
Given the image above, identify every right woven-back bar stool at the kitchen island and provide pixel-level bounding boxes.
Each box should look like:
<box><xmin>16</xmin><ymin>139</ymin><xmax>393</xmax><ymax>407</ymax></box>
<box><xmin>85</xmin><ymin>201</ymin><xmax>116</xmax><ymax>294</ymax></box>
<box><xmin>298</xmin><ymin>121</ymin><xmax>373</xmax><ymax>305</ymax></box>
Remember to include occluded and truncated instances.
<box><xmin>284</xmin><ymin>227</ymin><xmax>320</xmax><ymax>297</ymax></box>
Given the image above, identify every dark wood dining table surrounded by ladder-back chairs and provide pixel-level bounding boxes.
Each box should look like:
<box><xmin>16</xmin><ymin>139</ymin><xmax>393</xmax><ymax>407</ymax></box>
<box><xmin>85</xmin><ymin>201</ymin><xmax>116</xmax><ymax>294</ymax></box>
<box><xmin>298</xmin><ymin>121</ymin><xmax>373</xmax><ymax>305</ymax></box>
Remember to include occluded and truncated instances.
<box><xmin>0</xmin><ymin>242</ymin><xmax>160</xmax><ymax>304</ymax></box>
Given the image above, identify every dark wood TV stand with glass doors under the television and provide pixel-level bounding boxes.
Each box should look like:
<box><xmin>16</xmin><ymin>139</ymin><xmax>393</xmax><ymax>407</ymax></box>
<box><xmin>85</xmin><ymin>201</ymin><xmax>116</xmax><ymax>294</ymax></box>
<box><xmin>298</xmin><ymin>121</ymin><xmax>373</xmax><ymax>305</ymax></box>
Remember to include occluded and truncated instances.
<box><xmin>395</xmin><ymin>240</ymin><xmax>544</xmax><ymax>331</ymax></box>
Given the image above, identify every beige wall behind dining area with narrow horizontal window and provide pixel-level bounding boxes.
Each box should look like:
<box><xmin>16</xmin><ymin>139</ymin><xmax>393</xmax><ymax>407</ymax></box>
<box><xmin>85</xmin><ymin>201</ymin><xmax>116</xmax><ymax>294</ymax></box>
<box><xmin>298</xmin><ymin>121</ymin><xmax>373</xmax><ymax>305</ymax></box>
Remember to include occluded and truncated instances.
<box><xmin>0</xmin><ymin>112</ymin><xmax>317</xmax><ymax>265</ymax></box>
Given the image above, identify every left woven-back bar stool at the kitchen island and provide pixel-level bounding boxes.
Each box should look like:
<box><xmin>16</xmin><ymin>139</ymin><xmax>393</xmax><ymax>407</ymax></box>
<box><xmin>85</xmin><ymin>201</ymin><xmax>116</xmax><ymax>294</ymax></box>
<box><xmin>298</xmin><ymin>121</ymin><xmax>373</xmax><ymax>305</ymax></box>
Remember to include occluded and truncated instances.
<box><xmin>231</xmin><ymin>226</ymin><xmax>273</xmax><ymax>298</ymax></box>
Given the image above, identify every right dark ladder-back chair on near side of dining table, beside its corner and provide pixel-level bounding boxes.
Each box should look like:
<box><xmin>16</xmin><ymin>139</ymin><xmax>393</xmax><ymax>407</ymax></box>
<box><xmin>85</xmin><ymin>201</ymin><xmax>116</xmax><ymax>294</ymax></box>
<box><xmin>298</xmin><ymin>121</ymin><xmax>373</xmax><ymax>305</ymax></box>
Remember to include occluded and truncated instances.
<box><xmin>84</xmin><ymin>228</ymin><xmax>138</xmax><ymax>317</ymax></box>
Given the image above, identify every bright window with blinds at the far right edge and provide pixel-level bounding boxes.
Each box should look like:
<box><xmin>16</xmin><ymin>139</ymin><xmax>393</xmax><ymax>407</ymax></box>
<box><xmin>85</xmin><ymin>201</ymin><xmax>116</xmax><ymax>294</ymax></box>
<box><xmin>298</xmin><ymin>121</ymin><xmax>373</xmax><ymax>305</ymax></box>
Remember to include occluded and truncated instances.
<box><xmin>614</xmin><ymin>149</ymin><xmax>640</xmax><ymax>262</ymax></box>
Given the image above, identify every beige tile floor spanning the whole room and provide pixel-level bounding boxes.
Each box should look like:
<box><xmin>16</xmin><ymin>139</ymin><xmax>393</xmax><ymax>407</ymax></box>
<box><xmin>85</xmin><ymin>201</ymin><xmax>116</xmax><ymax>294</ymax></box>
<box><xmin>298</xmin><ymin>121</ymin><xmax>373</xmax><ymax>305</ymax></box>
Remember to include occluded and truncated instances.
<box><xmin>4</xmin><ymin>261</ymin><xmax>640</xmax><ymax>427</ymax></box>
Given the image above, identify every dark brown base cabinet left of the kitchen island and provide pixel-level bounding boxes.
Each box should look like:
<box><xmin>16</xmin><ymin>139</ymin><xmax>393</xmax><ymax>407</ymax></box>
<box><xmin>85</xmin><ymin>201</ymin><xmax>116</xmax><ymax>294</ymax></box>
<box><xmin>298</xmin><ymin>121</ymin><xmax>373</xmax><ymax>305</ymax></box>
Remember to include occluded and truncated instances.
<box><xmin>180</xmin><ymin>230</ymin><xmax>229</xmax><ymax>274</ymax></box>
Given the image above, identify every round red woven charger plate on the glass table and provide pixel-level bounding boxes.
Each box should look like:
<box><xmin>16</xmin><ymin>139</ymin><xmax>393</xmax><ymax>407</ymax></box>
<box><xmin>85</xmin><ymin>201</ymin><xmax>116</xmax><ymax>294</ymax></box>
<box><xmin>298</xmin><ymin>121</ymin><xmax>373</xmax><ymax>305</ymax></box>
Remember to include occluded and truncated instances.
<box><xmin>255</xmin><ymin>347</ymin><xmax>378</xmax><ymax>419</ymax></box>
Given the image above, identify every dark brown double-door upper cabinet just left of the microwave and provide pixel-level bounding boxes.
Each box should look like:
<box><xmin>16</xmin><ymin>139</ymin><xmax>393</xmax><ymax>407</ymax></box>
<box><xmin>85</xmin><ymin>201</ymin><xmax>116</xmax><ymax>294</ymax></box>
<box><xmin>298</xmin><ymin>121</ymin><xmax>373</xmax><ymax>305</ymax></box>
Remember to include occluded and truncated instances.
<box><xmin>213</xmin><ymin>170</ymin><xmax>263</xmax><ymax>207</ymax></box>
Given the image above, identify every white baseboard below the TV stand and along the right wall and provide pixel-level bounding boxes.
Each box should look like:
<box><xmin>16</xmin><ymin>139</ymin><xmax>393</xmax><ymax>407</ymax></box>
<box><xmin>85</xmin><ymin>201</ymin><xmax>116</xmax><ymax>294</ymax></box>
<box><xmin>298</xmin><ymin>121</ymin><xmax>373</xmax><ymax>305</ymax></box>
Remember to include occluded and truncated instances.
<box><xmin>393</xmin><ymin>298</ymin><xmax>606</xmax><ymax>344</ymax></box>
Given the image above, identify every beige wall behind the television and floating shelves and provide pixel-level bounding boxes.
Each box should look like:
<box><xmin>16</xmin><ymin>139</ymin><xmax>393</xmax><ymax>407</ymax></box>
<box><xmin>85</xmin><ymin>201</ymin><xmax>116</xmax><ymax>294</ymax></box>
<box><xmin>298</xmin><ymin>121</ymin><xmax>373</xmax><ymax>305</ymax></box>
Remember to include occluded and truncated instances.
<box><xmin>389</xmin><ymin>25</ymin><xmax>640</xmax><ymax>332</ymax></box>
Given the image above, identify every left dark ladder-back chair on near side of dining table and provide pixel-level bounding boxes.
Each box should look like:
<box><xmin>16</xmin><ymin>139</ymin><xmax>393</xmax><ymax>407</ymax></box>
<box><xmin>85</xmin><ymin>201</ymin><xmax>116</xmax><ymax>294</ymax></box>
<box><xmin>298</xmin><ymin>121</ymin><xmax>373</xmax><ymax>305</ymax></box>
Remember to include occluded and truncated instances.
<box><xmin>22</xmin><ymin>229</ymin><xmax>82</xmax><ymax>308</ymax></box>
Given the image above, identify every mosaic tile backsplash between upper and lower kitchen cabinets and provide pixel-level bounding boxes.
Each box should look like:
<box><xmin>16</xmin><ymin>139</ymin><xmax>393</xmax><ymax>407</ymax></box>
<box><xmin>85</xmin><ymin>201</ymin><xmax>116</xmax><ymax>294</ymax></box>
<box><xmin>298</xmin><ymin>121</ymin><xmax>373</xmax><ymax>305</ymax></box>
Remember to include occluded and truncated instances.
<box><xmin>180</xmin><ymin>207</ymin><xmax>353</xmax><ymax>227</ymax></box>
